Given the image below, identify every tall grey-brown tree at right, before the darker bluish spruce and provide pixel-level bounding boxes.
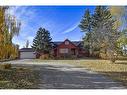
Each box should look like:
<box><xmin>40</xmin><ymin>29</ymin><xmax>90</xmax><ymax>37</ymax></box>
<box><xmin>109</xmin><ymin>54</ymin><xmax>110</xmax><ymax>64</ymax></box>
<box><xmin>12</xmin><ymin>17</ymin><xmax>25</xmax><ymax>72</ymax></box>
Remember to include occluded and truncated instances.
<box><xmin>92</xmin><ymin>6</ymin><xmax>119</xmax><ymax>62</ymax></box>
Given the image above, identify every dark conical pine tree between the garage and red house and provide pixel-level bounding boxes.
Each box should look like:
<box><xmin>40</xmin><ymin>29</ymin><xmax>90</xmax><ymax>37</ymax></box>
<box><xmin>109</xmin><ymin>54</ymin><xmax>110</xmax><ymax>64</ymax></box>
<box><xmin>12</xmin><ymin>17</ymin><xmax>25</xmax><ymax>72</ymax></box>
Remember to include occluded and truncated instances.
<box><xmin>32</xmin><ymin>28</ymin><xmax>52</xmax><ymax>54</ymax></box>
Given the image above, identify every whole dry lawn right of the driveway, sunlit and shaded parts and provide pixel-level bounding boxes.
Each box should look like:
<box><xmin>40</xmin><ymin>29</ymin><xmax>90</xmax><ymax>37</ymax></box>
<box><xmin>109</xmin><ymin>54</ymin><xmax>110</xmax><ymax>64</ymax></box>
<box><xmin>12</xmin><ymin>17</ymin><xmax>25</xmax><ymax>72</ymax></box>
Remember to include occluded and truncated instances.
<box><xmin>34</xmin><ymin>59</ymin><xmax>127</xmax><ymax>86</ymax></box>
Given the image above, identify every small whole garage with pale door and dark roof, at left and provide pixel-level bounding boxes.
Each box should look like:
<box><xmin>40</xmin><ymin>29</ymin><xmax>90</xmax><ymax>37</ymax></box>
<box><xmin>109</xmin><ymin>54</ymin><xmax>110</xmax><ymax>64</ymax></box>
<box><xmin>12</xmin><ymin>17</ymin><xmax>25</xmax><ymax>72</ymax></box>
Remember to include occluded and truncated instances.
<box><xmin>19</xmin><ymin>48</ymin><xmax>36</xmax><ymax>59</ymax></box>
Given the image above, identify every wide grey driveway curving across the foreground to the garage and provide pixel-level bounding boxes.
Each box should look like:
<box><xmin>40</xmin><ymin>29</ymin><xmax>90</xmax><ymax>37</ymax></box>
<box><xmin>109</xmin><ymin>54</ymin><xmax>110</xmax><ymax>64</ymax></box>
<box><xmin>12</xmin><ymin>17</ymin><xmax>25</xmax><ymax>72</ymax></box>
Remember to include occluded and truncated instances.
<box><xmin>7</xmin><ymin>60</ymin><xmax>124</xmax><ymax>89</ymax></box>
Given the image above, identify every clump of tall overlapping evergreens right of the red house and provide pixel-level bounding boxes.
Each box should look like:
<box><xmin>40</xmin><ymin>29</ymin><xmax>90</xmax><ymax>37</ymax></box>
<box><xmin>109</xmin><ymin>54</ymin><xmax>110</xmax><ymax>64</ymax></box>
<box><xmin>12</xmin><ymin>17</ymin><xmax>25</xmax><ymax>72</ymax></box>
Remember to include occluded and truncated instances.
<box><xmin>79</xmin><ymin>6</ymin><xmax>119</xmax><ymax>61</ymax></box>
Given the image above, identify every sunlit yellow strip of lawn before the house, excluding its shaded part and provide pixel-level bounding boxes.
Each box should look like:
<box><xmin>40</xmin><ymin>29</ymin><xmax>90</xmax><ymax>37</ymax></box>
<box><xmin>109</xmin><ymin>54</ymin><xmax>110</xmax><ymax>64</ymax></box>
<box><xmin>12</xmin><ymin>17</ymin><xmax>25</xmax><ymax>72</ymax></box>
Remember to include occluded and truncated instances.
<box><xmin>32</xmin><ymin>59</ymin><xmax>127</xmax><ymax>72</ymax></box>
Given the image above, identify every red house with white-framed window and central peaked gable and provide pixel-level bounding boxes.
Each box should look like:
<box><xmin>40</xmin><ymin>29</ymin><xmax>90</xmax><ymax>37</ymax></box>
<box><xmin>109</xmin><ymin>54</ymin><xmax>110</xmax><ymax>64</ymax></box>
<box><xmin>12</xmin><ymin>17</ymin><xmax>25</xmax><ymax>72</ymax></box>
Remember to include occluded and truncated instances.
<box><xmin>53</xmin><ymin>39</ymin><xmax>89</xmax><ymax>57</ymax></box>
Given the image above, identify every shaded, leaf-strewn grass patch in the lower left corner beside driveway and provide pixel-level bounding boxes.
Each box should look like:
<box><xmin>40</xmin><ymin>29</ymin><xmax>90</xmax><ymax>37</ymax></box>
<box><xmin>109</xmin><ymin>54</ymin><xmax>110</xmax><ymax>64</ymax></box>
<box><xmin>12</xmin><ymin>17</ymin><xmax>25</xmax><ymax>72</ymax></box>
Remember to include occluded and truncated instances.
<box><xmin>0</xmin><ymin>64</ymin><xmax>37</xmax><ymax>89</ymax></box>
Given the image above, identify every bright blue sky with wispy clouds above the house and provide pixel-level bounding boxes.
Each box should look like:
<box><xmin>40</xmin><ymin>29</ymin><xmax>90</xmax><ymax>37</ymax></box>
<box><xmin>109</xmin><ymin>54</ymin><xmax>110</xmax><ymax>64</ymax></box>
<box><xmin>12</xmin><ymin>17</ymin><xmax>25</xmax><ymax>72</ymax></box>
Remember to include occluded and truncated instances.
<box><xmin>10</xmin><ymin>6</ymin><xmax>95</xmax><ymax>48</ymax></box>
